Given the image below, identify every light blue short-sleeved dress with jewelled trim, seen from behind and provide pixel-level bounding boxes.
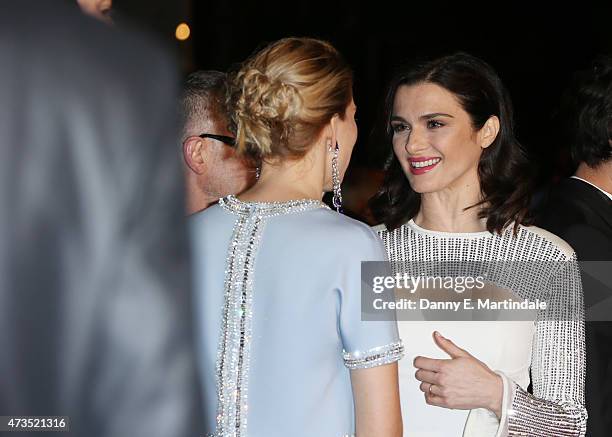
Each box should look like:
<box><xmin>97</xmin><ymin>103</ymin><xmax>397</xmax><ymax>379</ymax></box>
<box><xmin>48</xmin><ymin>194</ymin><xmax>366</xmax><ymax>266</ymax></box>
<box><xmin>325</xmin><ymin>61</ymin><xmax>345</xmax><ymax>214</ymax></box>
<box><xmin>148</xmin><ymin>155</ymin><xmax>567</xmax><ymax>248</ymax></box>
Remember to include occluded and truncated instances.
<box><xmin>191</xmin><ymin>196</ymin><xmax>403</xmax><ymax>437</ymax></box>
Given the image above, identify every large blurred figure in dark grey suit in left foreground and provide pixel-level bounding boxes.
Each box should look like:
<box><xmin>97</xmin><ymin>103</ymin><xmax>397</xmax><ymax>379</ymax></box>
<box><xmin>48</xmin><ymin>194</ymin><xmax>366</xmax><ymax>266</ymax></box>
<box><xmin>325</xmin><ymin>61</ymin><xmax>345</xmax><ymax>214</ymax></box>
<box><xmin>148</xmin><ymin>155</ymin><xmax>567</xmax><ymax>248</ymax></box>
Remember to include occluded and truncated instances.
<box><xmin>0</xmin><ymin>0</ymin><xmax>202</xmax><ymax>437</ymax></box>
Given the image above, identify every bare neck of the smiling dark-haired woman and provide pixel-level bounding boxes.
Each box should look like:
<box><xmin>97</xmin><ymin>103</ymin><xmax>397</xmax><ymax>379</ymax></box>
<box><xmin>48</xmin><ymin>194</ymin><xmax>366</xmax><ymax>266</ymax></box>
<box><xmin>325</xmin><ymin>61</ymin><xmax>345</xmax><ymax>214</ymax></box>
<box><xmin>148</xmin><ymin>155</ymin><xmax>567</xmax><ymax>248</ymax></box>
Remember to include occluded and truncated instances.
<box><xmin>414</xmin><ymin>185</ymin><xmax>487</xmax><ymax>233</ymax></box>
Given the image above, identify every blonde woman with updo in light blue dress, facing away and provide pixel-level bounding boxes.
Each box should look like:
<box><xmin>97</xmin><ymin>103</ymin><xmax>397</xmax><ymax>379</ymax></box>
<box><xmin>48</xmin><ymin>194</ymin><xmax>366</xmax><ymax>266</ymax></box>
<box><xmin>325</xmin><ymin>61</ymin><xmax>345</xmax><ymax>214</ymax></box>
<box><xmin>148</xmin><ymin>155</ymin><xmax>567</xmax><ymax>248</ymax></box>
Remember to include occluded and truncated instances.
<box><xmin>192</xmin><ymin>38</ymin><xmax>403</xmax><ymax>437</ymax></box>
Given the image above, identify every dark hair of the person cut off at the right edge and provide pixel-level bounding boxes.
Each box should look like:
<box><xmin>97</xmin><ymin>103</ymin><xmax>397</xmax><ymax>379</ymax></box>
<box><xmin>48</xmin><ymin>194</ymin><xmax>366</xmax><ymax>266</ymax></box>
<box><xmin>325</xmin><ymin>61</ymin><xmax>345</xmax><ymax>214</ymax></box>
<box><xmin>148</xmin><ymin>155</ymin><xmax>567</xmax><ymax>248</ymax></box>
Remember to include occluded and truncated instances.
<box><xmin>561</xmin><ymin>55</ymin><xmax>612</xmax><ymax>167</ymax></box>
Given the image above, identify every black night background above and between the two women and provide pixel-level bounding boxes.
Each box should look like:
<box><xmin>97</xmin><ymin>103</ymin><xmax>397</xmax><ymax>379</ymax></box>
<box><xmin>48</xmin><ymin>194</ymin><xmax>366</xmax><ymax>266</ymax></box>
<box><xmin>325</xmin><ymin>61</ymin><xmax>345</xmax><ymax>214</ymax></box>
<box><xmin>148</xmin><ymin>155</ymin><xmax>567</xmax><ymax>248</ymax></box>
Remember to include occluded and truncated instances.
<box><xmin>115</xmin><ymin>0</ymin><xmax>612</xmax><ymax>221</ymax></box>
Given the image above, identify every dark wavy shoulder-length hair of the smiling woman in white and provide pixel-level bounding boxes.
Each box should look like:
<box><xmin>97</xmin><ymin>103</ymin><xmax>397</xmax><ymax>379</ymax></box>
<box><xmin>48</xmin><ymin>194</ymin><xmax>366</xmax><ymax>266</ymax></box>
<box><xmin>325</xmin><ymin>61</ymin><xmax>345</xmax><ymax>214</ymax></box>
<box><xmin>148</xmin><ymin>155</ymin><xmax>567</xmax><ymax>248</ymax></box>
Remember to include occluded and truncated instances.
<box><xmin>370</xmin><ymin>53</ymin><xmax>532</xmax><ymax>233</ymax></box>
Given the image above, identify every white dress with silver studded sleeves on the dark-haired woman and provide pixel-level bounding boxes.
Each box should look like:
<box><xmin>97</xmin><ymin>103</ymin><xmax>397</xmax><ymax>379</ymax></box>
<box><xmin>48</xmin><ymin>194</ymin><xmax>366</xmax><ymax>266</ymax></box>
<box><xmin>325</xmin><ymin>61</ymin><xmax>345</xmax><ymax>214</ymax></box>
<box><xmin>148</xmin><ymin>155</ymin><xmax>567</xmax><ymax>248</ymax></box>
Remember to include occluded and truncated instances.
<box><xmin>376</xmin><ymin>220</ymin><xmax>587</xmax><ymax>437</ymax></box>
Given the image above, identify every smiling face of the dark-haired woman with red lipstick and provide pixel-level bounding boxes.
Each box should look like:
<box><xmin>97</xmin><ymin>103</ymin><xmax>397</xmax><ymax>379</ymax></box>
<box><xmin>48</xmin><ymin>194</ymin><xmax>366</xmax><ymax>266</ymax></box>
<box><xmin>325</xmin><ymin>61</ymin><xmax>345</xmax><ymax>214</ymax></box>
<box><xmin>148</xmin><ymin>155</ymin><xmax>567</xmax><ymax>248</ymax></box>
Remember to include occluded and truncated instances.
<box><xmin>391</xmin><ymin>82</ymin><xmax>490</xmax><ymax>193</ymax></box>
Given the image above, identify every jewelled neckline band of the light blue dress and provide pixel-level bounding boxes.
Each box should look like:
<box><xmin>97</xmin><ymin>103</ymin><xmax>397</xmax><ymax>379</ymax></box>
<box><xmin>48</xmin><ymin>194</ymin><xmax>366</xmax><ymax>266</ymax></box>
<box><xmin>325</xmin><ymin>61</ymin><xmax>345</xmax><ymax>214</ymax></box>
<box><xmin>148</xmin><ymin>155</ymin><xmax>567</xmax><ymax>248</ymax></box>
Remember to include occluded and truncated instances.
<box><xmin>219</xmin><ymin>195</ymin><xmax>330</xmax><ymax>217</ymax></box>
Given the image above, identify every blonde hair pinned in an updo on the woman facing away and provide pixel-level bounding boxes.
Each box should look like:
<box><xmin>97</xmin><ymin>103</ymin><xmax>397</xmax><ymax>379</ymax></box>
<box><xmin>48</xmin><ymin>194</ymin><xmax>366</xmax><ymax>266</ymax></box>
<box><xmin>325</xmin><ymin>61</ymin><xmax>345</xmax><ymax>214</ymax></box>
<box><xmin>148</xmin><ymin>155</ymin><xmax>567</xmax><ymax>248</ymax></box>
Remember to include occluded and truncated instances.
<box><xmin>228</xmin><ymin>38</ymin><xmax>353</xmax><ymax>163</ymax></box>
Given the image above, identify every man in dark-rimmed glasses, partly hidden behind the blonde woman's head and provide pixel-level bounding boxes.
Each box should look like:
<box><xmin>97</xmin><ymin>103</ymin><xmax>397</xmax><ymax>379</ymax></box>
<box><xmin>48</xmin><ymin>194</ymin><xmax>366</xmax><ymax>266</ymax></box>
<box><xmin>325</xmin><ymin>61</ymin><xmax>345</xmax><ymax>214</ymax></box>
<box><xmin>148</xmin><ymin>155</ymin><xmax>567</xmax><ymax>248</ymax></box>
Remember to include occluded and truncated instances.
<box><xmin>180</xmin><ymin>71</ymin><xmax>256</xmax><ymax>214</ymax></box>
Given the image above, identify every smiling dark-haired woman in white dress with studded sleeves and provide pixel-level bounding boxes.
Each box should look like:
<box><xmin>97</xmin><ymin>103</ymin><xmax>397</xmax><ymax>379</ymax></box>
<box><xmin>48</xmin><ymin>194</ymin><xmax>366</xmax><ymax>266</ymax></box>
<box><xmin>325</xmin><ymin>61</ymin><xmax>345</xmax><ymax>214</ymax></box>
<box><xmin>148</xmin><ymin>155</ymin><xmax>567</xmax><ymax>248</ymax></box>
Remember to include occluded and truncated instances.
<box><xmin>372</xmin><ymin>53</ymin><xmax>586</xmax><ymax>437</ymax></box>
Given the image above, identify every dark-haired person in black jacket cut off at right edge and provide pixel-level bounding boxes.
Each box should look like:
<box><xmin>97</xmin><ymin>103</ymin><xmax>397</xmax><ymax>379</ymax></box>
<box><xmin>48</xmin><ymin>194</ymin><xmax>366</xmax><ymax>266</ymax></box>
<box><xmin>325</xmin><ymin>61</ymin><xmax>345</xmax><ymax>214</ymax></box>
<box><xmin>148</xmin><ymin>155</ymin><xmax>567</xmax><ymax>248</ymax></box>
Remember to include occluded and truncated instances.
<box><xmin>538</xmin><ymin>56</ymin><xmax>612</xmax><ymax>437</ymax></box>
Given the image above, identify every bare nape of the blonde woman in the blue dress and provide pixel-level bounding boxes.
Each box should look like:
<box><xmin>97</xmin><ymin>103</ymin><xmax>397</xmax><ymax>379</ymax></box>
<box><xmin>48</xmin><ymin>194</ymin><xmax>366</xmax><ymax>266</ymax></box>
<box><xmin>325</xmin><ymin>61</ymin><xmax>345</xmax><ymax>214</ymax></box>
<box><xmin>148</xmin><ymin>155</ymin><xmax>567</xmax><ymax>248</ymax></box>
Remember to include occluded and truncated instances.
<box><xmin>238</xmin><ymin>147</ymin><xmax>325</xmax><ymax>202</ymax></box>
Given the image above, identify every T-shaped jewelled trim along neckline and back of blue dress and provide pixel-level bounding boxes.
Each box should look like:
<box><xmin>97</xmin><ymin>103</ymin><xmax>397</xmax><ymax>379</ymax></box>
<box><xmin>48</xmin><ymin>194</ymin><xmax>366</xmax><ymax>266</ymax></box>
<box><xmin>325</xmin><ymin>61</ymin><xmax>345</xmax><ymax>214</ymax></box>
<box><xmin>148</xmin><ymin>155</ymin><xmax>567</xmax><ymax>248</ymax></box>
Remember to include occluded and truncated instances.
<box><xmin>214</xmin><ymin>196</ymin><xmax>329</xmax><ymax>437</ymax></box>
